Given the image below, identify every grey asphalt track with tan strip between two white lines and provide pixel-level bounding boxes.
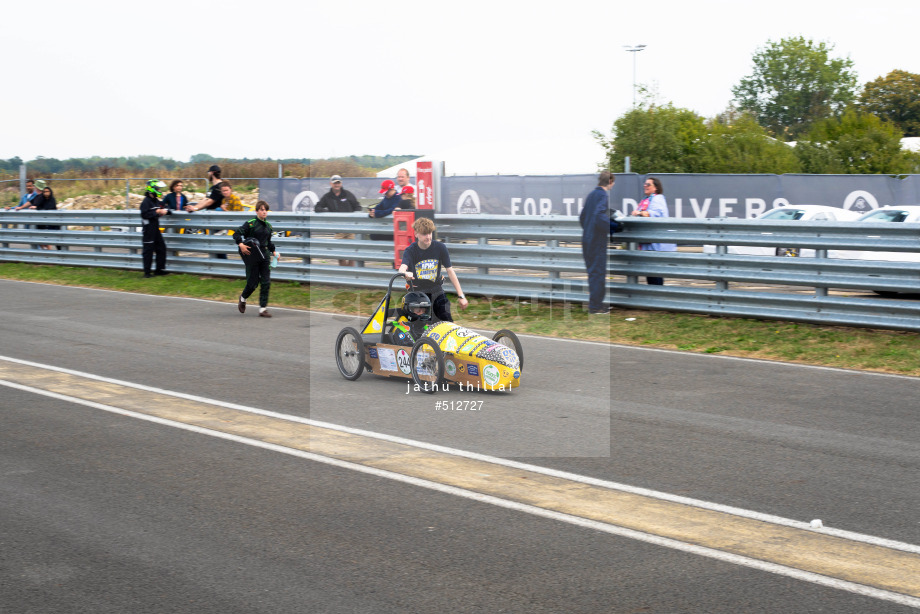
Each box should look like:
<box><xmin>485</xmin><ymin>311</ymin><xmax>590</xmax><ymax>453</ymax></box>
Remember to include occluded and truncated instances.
<box><xmin>0</xmin><ymin>281</ymin><xmax>920</xmax><ymax>612</ymax></box>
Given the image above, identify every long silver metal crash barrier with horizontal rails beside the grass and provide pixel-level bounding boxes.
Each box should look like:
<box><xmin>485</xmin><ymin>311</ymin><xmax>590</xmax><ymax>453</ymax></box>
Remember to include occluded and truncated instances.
<box><xmin>0</xmin><ymin>210</ymin><xmax>920</xmax><ymax>331</ymax></box>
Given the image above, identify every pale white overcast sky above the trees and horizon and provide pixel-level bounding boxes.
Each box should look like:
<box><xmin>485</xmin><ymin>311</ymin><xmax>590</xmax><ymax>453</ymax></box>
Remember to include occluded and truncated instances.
<box><xmin>0</xmin><ymin>0</ymin><xmax>920</xmax><ymax>161</ymax></box>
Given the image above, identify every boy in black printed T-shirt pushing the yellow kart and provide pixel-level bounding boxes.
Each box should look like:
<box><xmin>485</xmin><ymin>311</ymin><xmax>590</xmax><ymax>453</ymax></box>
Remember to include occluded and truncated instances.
<box><xmin>399</xmin><ymin>217</ymin><xmax>470</xmax><ymax>322</ymax></box>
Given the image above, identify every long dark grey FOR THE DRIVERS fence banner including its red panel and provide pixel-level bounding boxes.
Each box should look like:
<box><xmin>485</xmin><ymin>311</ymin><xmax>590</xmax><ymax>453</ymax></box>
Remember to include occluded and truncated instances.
<box><xmin>259</xmin><ymin>173</ymin><xmax>920</xmax><ymax>219</ymax></box>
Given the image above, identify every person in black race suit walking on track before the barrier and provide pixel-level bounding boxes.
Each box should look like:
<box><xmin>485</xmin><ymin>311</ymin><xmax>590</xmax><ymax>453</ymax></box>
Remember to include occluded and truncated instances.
<box><xmin>233</xmin><ymin>200</ymin><xmax>278</xmax><ymax>318</ymax></box>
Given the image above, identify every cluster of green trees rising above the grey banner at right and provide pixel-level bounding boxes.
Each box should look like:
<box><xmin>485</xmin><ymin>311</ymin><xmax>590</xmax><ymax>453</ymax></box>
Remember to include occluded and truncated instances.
<box><xmin>594</xmin><ymin>37</ymin><xmax>920</xmax><ymax>174</ymax></box>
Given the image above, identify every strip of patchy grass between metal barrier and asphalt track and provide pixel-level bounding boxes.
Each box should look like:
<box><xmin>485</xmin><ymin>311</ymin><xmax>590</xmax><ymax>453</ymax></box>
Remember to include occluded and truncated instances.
<box><xmin>0</xmin><ymin>263</ymin><xmax>920</xmax><ymax>376</ymax></box>
